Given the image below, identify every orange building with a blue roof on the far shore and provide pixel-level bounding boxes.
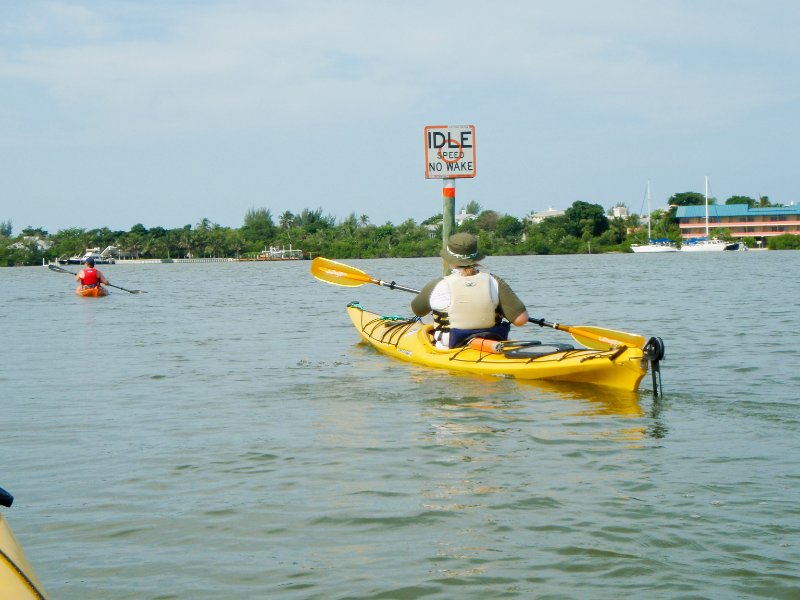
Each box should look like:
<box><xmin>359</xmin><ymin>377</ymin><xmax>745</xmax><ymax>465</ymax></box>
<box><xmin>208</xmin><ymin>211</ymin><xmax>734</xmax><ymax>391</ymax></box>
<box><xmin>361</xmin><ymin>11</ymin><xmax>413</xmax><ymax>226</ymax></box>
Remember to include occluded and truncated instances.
<box><xmin>675</xmin><ymin>204</ymin><xmax>800</xmax><ymax>242</ymax></box>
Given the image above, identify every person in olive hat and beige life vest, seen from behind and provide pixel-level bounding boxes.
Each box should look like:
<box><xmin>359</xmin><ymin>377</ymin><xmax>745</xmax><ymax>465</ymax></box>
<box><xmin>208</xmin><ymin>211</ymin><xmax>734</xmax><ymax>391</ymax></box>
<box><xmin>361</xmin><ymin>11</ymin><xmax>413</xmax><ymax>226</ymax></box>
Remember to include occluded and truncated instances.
<box><xmin>411</xmin><ymin>233</ymin><xmax>528</xmax><ymax>348</ymax></box>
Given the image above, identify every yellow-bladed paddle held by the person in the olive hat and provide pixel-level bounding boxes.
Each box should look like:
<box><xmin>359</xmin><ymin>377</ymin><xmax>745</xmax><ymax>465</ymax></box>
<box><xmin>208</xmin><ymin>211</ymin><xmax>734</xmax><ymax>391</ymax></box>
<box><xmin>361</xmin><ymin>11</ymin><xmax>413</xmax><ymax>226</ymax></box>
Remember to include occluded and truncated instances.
<box><xmin>311</xmin><ymin>256</ymin><xmax>646</xmax><ymax>350</ymax></box>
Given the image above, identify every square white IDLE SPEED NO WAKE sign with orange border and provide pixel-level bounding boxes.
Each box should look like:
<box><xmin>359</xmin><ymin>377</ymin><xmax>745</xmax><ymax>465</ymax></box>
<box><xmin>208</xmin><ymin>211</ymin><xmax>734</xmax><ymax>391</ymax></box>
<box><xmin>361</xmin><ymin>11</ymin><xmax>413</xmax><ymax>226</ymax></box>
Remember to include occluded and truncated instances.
<box><xmin>425</xmin><ymin>125</ymin><xmax>475</xmax><ymax>179</ymax></box>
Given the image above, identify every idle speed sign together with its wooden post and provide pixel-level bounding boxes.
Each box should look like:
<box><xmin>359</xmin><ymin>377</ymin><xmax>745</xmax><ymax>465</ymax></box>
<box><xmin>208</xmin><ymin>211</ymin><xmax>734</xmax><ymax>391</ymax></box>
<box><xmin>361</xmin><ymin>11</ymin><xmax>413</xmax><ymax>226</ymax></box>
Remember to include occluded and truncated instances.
<box><xmin>425</xmin><ymin>125</ymin><xmax>476</xmax><ymax>275</ymax></box>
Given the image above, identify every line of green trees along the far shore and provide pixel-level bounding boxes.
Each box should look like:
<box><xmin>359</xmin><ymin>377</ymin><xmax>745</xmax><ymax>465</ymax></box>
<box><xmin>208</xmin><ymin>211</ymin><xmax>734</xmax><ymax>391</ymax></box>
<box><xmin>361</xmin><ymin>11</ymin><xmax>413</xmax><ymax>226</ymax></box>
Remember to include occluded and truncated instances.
<box><xmin>0</xmin><ymin>192</ymin><xmax>800</xmax><ymax>266</ymax></box>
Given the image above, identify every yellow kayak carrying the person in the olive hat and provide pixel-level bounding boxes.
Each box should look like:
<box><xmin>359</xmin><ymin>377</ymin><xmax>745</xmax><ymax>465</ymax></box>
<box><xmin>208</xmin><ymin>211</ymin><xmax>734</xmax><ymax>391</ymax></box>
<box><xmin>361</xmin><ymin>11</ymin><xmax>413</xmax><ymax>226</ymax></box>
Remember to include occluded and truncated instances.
<box><xmin>347</xmin><ymin>302</ymin><xmax>648</xmax><ymax>391</ymax></box>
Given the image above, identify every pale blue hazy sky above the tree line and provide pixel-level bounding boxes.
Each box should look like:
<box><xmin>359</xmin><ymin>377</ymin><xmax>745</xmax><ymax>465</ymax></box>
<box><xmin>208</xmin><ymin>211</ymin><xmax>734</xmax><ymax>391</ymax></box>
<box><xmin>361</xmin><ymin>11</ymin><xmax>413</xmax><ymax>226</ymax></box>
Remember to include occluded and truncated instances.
<box><xmin>0</xmin><ymin>0</ymin><xmax>800</xmax><ymax>234</ymax></box>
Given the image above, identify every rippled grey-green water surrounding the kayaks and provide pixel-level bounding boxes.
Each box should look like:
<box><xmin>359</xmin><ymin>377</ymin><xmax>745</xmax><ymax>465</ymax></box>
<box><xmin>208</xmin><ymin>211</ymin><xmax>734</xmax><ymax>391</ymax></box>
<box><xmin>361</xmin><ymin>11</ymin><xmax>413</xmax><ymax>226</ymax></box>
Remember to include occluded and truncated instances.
<box><xmin>0</xmin><ymin>252</ymin><xmax>800</xmax><ymax>600</ymax></box>
